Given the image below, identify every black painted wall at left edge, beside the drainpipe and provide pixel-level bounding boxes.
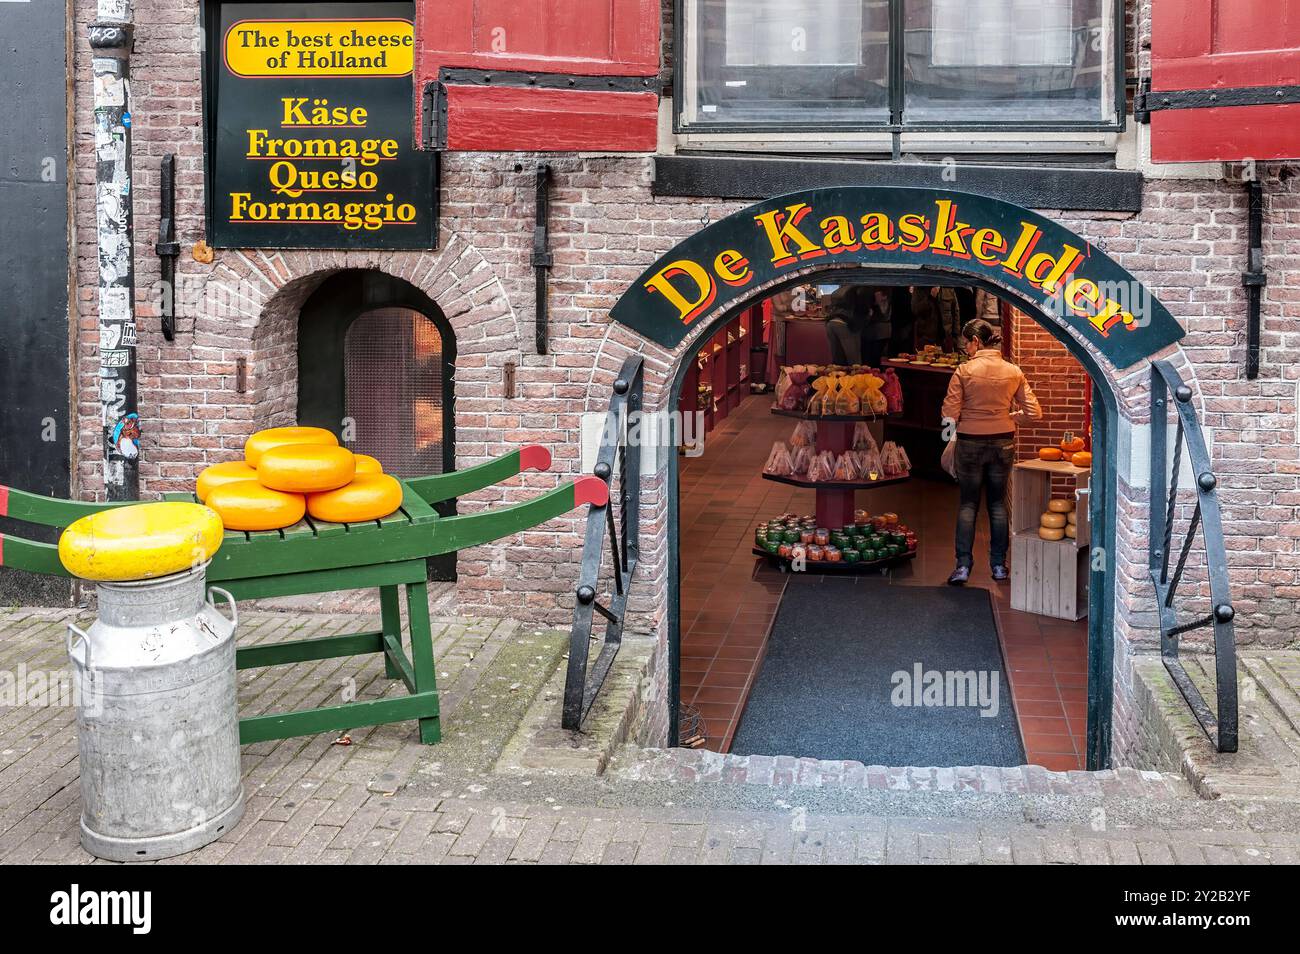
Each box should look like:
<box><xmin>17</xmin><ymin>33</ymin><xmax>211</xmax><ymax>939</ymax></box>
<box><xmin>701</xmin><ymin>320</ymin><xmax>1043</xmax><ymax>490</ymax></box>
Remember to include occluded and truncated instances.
<box><xmin>0</xmin><ymin>0</ymin><xmax>70</xmax><ymax>604</ymax></box>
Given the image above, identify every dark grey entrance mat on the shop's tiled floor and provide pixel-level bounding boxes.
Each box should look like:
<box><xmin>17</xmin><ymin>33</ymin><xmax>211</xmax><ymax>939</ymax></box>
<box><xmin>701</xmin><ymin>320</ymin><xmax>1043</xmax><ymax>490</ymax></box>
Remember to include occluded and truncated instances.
<box><xmin>731</xmin><ymin>576</ymin><xmax>1024</xmax><ymax>766</ymax></box>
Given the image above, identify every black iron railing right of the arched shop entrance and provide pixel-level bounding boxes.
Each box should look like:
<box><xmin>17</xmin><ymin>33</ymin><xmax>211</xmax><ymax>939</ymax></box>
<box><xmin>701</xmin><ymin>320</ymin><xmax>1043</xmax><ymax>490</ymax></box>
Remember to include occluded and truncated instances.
<box><xmin>1148</xmin><ymin>361</ymin><xmax>1238</xmax><ymax>753</ymax></box>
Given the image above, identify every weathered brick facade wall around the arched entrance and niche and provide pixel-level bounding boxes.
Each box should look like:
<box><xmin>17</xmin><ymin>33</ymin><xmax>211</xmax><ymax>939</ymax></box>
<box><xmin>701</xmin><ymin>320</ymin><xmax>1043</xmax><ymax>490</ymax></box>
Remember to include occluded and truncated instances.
<box><xmin>61</xmin><ymin>0</ymin><xmax>1300</xmax><ymax>764</ymax></box>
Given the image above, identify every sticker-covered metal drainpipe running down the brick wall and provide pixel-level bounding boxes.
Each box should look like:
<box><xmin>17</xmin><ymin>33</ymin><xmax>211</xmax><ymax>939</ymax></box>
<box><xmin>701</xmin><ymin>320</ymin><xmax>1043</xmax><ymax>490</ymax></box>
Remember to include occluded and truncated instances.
<box><xmin>88</xmin><ymin>0</ymin><xmax>140</xmax><ymax>500</ymax></box>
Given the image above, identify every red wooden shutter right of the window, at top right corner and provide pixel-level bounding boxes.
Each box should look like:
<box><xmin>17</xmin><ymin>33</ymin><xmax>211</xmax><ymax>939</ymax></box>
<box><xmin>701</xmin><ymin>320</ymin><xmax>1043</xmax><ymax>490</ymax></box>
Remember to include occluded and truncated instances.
<box><xmin>1151</xmin><ymin>0</ymin><xmax>1300</xmax><ymax>162</ymax></box>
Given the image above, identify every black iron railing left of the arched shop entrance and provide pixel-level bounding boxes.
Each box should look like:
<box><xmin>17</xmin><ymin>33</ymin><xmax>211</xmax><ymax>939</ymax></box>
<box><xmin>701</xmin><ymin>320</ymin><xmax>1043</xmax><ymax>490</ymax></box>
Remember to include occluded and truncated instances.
<box><xmin>562</xmin><ymin>355</ymin><xmax>645</xmax><ymax>730</ymax></box>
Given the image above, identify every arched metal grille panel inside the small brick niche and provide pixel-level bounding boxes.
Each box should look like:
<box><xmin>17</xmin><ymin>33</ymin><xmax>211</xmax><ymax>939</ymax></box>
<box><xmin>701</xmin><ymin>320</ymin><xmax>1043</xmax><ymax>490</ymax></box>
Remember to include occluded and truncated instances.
<box><xmin>343</xmin><ymin>308</ymin><xmax>443</xmax><ymax>477</ymax></box>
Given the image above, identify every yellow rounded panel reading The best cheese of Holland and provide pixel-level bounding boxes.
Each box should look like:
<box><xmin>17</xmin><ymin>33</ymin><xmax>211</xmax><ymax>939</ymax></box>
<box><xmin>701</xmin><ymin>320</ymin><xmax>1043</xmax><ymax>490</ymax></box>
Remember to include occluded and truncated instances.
<box><xmin>222</xmin><ymin>18</ymin><xmax>415</xmax><ymax>78</ymax></box>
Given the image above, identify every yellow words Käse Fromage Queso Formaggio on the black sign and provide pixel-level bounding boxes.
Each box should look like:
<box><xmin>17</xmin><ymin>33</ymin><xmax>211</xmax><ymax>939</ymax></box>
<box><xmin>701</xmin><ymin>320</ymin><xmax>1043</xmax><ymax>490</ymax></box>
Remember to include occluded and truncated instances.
<box><xmin>230</xmin><ymin>96</ymin><xmax>416</xmax><ymax>231</ymax></box>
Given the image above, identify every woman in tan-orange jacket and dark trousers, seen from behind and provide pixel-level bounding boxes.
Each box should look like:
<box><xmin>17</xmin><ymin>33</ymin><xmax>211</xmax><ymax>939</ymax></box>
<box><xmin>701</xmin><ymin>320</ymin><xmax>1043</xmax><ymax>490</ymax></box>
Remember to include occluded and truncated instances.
<box><xmin>943</xmin><ymin>318</ymin><xmax>1043</xmax><ymax>586</ymax></box>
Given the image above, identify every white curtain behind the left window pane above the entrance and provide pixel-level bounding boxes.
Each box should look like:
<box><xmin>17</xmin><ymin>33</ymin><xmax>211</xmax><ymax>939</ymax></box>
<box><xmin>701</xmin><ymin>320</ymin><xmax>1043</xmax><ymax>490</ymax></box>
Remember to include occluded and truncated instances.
<box><xmin>727</xmin><ymin>0</ymin><xmax>862</xmax><ymax>66</ymax></box>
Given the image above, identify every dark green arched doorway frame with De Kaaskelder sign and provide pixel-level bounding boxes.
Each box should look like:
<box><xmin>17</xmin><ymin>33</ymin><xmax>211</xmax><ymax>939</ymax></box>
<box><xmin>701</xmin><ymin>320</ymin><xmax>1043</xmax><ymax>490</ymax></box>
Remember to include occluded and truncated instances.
<box><xmin>611</xmin><ymin>188</ymin><xmax>1183</xmax><ymax>769</ymax></box>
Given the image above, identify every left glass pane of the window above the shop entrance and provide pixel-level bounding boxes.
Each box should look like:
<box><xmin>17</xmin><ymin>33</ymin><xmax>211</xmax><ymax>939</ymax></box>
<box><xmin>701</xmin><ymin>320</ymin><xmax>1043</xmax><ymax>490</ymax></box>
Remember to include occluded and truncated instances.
<box><xmin>684</xmin><ymin>0</ymin><xmax>889</xmax><ymax>126</ymax></box>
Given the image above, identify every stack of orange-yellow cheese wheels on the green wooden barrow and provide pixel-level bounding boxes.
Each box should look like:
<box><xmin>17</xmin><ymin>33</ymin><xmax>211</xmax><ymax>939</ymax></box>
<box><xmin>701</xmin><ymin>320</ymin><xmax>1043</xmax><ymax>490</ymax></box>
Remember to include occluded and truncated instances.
<box><xmin>195</xmin><ymin>428</ymin><xmax>402</xmax><ymax>530</ymax></box>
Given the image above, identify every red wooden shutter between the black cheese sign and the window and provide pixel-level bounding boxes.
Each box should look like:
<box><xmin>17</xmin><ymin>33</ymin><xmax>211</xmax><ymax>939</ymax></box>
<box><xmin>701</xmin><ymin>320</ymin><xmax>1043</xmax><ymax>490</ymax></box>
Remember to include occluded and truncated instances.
<box><xmin>416</xmin><ymin>0</ymin><xmax>660</xmax><ymax>152</ymax></box>
